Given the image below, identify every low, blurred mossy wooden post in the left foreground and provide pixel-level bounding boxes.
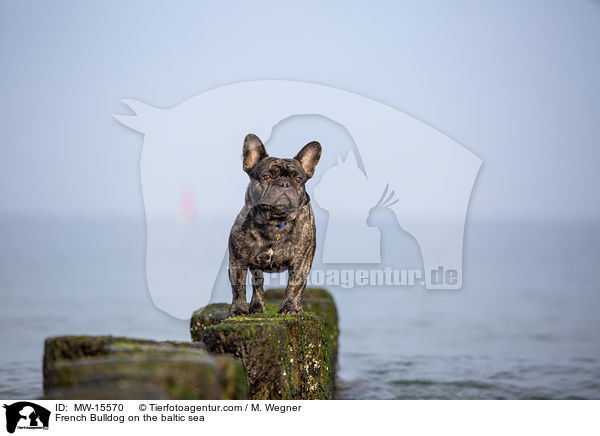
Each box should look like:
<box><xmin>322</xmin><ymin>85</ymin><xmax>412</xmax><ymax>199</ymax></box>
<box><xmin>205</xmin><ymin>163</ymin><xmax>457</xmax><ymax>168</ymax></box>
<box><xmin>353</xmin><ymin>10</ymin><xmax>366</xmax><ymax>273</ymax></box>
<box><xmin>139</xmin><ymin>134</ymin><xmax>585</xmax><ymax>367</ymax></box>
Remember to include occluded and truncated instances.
<box><xmin>43</xmin><ymin>336</ymin><xmax>248</xmax><ymax>400</ymax></box>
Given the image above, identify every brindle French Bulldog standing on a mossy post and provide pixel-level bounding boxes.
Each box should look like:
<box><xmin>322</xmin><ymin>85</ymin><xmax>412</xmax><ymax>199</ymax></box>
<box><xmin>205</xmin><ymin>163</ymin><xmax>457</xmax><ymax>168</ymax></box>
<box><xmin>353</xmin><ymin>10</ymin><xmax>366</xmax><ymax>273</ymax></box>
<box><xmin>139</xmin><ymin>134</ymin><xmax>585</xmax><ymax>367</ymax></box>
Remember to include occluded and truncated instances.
<box><xmin>229</xmin><ymin>134</ymin><xmax>321</xmax><ymax>316</ymax></box>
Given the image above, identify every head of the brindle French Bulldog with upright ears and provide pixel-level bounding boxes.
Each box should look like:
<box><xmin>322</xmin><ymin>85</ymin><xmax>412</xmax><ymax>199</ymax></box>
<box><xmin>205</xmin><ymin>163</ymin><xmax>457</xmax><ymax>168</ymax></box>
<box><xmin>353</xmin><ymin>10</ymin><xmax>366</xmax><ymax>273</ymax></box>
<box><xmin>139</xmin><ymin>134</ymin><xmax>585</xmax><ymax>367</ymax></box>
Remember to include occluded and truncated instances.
<box><xmin>243</xmin><ymin>134</ymin><xmax>321</xmax><ymax>224</ymax></box>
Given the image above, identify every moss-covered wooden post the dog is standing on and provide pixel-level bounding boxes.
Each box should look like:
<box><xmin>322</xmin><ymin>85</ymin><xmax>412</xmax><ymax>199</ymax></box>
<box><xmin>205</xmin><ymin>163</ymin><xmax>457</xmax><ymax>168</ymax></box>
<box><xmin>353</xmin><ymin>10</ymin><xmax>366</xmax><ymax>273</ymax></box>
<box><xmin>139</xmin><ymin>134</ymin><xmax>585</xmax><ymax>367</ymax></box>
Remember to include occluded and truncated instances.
<box><xmin>191</xmin><ymin>289</ymin><xmax>338</xmax><ymax>399</ymax></box>
